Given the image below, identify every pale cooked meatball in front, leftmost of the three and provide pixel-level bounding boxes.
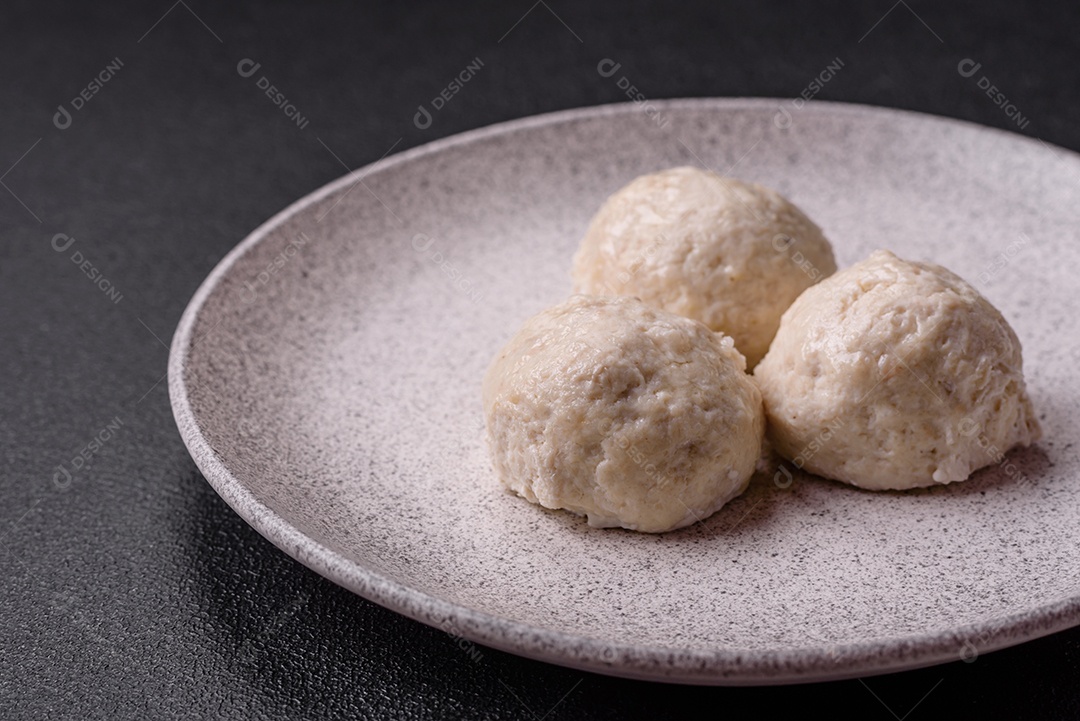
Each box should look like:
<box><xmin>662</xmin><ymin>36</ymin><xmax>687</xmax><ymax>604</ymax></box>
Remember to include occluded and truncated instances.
<box><xmin>483</xmin><ymin>296</ymin><xmax>765</xmax><ymax>533</ymax></box>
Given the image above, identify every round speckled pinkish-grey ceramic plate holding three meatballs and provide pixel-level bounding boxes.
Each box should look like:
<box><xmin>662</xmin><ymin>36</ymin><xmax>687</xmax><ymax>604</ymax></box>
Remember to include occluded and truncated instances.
<box><xmin>168</xmin><ymin>99</ymin><xmax>1080</xmax><ymax>684</ymax></box>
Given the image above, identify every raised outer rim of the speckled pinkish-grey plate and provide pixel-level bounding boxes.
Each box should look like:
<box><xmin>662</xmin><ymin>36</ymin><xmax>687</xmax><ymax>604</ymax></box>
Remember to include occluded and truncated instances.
<box><xmin>167</xmin><ymin>97</ymin><xmax>1080</xmax><ymax>685</ymax></box>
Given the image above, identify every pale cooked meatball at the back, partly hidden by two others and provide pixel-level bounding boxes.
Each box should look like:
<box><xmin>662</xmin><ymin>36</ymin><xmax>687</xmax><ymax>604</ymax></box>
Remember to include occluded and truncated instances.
<box><xmin>571</xmin><ymin>167</ymin><xmax>836</xmax><ymax>368</ymax></box>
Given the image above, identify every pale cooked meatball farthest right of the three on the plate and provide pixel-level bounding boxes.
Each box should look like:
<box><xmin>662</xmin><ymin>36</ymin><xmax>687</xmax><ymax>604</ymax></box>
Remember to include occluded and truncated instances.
<box><xmin>754</xmin><ymin>250</ymin><xmax>1040</xmax><ymax>490</ymax></box>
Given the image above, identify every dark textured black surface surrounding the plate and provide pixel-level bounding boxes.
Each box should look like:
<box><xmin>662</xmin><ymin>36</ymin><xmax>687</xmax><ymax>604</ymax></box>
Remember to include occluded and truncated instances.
<box><xmin>0</xmin><ymin>0</ymin><xmax>1080</xmax><ymax>719</ymax></box>
